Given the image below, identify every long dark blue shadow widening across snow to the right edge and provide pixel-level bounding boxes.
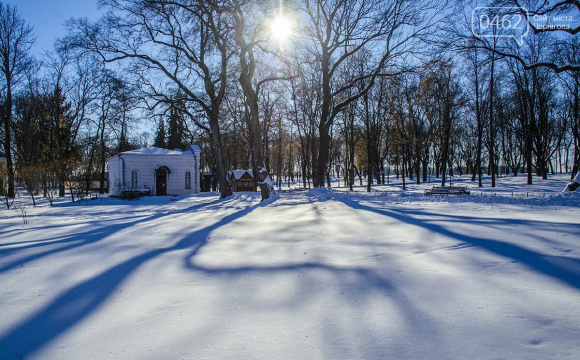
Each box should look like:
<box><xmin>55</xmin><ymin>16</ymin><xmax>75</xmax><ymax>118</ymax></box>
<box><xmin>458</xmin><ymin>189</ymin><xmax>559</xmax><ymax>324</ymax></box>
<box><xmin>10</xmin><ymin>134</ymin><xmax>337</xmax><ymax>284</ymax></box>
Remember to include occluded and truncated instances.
<box><xmin>340</xmin><ymin>195</ymin><xmax>580</xmax><ymax>289</ymax></box>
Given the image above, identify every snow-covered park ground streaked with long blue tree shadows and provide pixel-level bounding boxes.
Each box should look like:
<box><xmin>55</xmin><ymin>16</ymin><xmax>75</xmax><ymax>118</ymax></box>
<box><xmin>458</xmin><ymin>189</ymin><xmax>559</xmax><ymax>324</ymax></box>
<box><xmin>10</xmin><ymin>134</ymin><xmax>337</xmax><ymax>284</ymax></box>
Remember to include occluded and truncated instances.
<box><xmin>0</xmin><ymin>175</ymin><xmax>580</xmax><ymax>360</ymax></box>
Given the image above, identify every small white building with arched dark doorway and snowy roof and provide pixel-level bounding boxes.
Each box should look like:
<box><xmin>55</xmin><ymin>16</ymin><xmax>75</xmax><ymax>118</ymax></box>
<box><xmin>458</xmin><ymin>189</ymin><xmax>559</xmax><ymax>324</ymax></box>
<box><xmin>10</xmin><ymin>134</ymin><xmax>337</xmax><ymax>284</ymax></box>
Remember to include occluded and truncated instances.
<box><xmin>108</xmin><ymin>145</ymin><xmax>201</xmax><ymax>196</ymax></box>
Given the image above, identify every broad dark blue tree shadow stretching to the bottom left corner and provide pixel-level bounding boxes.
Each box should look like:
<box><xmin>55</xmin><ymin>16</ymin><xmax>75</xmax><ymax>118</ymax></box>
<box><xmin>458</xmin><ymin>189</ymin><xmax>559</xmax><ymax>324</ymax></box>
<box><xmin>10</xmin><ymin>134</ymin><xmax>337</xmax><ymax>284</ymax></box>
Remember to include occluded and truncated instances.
<box><xmin>0</xmin><ymin>200</ymin><xmax>259</xmax><ymax>358</ymax></box>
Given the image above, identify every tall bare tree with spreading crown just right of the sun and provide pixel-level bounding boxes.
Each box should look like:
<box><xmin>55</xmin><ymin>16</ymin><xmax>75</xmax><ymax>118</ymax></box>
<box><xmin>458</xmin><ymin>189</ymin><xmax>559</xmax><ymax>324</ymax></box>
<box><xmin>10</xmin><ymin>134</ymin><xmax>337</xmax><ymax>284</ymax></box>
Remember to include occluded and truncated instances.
<box><xmin>298</xmin><ymin>0</ymin><xmax>441</xmax><ymax>187</ymax></box>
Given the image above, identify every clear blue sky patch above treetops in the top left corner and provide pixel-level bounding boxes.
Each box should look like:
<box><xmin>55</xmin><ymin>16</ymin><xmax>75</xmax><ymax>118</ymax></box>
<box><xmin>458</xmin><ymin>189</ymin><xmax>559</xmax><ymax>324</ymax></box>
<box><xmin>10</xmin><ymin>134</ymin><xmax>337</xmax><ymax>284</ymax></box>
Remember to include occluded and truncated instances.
<box><xmin>0</xmin><ymin>0</ymin><xmax>99</xmax><ymax>55</ymax></box>
